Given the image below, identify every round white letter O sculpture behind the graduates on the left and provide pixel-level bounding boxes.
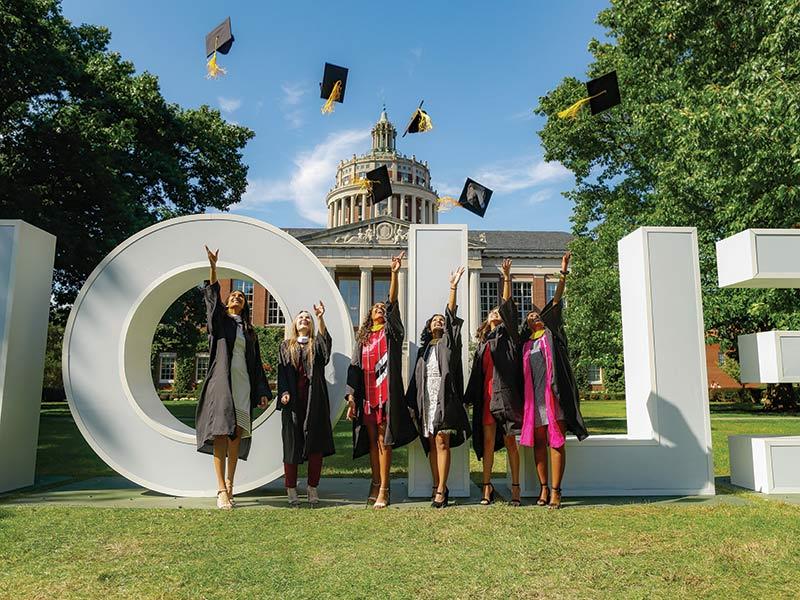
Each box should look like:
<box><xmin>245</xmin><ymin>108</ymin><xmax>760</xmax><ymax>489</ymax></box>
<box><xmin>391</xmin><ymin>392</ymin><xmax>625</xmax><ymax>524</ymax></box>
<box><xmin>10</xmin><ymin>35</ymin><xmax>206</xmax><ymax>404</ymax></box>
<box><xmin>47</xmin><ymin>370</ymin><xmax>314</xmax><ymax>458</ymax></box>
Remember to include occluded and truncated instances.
<box><xmin>63</xmin><ymin>214</ymin><xmax>353</xmax><ymax>496</ymax></box>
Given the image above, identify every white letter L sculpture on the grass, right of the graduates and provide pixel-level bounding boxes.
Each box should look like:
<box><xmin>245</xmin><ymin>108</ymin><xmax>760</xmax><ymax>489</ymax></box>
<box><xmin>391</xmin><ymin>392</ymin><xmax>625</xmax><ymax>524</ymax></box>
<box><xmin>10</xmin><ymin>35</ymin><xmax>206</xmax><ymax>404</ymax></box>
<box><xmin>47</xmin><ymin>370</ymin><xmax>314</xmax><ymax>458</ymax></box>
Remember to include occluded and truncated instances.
<box><xmin>522</xmin><ymin>227</ymin><xmax>714</xmax><ymax>496</ymax></box>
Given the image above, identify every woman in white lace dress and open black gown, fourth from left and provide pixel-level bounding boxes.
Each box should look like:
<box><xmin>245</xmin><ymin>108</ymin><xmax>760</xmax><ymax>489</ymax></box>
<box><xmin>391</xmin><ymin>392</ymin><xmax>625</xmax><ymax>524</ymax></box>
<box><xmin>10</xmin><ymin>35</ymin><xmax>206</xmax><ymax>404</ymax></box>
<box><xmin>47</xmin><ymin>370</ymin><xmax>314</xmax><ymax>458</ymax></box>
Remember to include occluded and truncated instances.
<box><xmin>406</xmin><ymin>267</ymin><xmax>470</xmax><ymax>508</ymax></box>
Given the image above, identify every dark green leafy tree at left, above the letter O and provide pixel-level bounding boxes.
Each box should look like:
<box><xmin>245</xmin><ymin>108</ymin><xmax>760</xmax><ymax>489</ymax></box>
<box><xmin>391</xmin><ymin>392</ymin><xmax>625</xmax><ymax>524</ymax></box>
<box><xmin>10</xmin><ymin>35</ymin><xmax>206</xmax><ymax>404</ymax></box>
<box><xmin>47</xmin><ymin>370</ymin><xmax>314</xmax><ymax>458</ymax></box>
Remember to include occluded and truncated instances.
<box><xmin>0</xmin><ymin>0</ymin><xmax>254</xmax><ymax>306</ymax></box>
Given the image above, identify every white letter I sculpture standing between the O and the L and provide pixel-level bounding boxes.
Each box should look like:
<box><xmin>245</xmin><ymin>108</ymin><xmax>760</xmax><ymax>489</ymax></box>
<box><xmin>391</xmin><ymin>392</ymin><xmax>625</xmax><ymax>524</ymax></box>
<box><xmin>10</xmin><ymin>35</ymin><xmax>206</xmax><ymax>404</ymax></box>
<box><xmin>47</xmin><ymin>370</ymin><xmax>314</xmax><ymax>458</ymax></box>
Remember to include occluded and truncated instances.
<box><xmin>406</xmin><ymin>225</ymin><xmax>470</xmax><ymax>498</ymax></box>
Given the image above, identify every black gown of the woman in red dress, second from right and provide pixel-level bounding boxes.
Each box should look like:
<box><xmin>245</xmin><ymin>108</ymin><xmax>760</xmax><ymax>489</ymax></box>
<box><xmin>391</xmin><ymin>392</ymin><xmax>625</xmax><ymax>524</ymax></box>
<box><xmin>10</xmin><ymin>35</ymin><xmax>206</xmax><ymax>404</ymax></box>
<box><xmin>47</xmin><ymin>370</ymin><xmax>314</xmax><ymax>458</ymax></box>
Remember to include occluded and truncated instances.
<box><xmin>464</xmin><ymin>298</ymin><xmax>523</xmax><ymax>459</ymax></box>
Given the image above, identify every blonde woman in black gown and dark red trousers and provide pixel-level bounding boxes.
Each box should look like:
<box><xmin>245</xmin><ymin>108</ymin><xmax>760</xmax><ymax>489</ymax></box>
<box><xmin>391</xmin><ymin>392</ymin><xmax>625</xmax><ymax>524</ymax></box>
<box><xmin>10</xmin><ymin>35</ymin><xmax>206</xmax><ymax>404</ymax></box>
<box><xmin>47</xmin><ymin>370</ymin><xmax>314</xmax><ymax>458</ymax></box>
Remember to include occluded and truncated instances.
<box><xmin>277</xmin><ymin>300</ymin><xmax>336</xmax><ymax>507</ymax></box>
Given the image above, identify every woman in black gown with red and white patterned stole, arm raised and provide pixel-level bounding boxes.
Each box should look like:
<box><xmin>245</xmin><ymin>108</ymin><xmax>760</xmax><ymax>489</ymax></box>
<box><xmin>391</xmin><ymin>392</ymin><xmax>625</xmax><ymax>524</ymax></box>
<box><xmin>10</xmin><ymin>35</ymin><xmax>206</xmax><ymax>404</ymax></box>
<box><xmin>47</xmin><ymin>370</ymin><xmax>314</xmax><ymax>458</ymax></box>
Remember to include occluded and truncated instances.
<box><xmin>347</xmin><ymin>252</ymin><xmax>417</xmax><ymax>508</ymax></box>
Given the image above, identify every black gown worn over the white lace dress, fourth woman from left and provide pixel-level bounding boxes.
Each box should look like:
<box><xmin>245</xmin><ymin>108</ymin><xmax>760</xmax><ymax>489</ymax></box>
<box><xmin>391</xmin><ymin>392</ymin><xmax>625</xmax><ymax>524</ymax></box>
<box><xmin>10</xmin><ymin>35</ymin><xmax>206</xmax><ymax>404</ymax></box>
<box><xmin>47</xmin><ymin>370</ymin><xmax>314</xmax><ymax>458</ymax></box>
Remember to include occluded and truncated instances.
<box><xmin>406</xmin><ymin>307</ymin><xmax>471</xmax><ymax>454</ymax></box>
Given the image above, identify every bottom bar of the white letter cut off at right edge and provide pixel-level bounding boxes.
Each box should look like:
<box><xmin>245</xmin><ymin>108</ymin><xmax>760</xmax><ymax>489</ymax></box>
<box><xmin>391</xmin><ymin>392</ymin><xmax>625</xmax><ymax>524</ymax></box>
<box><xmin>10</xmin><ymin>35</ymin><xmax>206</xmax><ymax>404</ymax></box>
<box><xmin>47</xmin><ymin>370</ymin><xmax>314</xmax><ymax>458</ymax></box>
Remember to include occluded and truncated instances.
<box><xmin>728</xmin><ymin>435</ymin><xmax>800</xmax><ymax>494</ymax></box>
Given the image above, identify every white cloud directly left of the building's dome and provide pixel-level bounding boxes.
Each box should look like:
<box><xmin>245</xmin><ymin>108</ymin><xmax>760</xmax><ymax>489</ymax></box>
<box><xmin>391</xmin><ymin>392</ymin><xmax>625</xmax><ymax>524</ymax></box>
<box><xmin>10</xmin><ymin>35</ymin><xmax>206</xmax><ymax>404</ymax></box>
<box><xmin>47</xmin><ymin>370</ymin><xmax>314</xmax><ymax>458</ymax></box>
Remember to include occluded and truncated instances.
<box><xmin>236</xmin><ymin>128</ymin><xmax>370</xmax><ymax>225</ymax></box>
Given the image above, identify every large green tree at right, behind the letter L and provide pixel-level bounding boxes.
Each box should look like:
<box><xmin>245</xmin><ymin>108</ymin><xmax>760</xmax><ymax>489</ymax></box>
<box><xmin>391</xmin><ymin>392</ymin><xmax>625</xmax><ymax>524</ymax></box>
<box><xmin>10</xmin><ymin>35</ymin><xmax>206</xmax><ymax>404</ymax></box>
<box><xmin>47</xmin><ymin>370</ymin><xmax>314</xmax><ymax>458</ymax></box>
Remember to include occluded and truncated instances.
<box><xmin>537</xmin><ymin>0</ymin><xmax>800</xmax><ymax>403</ymax></box>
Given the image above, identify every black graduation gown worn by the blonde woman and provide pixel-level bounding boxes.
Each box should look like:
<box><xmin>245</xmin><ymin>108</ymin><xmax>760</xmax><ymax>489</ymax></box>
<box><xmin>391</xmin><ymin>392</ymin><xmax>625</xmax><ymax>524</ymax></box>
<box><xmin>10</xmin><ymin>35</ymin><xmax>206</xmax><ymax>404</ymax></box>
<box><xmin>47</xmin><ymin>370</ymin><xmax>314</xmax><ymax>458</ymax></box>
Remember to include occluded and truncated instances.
<box><xmin>276</xmin><ymin>331</ymin><xmax>336</xmax><ymax>465</ymax></box>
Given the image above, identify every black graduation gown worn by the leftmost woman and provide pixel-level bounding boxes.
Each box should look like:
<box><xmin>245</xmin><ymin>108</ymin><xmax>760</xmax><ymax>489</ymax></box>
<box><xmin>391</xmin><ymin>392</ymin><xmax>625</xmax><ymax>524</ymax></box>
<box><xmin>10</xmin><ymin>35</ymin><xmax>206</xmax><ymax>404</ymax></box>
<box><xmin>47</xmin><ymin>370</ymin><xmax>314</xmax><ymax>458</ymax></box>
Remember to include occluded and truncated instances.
<box><xmin>195</xmin><ymin>281</ymin><xmax>272</xmax><ymax>460</ymax></box>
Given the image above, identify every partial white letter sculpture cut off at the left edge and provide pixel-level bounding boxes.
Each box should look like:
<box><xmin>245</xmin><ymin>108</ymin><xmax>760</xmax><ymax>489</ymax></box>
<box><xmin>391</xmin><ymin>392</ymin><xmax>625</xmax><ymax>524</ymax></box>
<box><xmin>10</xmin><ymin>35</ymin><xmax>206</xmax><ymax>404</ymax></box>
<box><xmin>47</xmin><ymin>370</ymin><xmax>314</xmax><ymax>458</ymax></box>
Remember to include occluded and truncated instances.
<box><xmin>0</xmin><ymin>220</ymin><xmax>56</xmax><ymax>492</ymax></box>
